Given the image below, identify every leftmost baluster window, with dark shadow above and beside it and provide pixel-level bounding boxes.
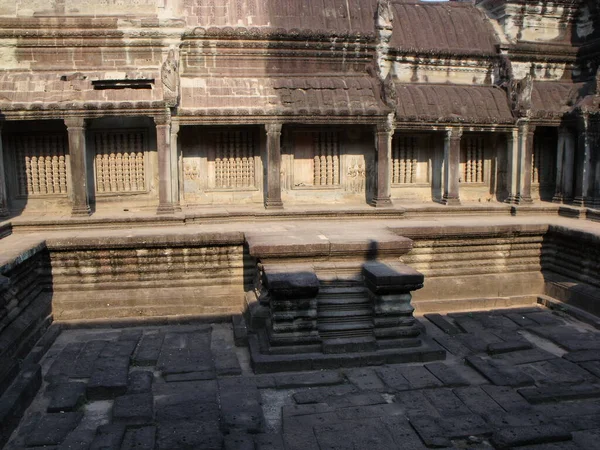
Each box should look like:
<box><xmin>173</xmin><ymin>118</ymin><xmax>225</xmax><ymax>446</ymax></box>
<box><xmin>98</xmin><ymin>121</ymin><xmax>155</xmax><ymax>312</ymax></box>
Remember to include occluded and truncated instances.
<box><xmin>6</xmin><ymin>133</ymin><xmax>67</xmax><ymax>197</ymax></box>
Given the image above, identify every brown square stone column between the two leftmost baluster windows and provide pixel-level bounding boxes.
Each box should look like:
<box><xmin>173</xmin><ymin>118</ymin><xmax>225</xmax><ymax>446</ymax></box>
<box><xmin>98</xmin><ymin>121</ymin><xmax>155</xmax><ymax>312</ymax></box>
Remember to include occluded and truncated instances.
<box><xmin>65</xmin><ymin>117</ymin><xmax>91</xmax><ymax>216</ymax></box>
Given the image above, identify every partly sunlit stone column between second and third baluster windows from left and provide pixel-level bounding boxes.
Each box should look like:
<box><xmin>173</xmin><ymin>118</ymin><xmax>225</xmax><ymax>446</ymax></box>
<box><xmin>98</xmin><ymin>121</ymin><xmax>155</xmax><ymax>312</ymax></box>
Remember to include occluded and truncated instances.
<box><xmin>154</xmin><ymin>116</ymin><xmax>175</xmax><ymax>214</ymax></box>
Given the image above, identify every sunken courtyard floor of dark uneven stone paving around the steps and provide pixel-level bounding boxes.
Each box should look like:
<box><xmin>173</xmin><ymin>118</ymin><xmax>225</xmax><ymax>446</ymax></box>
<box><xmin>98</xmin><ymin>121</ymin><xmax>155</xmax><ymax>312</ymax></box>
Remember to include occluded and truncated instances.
<box><xmin>5</xmin><ymin>307</ymin><xmax>600</xmax><ymax>450</ymax></box>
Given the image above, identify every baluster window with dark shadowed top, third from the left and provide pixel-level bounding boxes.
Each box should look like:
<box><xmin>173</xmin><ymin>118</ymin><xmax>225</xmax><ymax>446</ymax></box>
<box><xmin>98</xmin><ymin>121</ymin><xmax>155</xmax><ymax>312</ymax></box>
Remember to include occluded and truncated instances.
<box><xmin>211</xmin><ymin>130</ymin><xmax>256</xmax><ymax>189</ymax></box>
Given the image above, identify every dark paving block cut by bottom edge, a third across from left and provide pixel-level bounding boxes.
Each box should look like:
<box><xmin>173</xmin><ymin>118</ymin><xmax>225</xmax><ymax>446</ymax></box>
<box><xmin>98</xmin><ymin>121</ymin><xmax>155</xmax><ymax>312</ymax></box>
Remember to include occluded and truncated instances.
<box><xmin>157</xmin><ymin>420</ymin><xmax>223</xmax><ymax>450</ymax></box>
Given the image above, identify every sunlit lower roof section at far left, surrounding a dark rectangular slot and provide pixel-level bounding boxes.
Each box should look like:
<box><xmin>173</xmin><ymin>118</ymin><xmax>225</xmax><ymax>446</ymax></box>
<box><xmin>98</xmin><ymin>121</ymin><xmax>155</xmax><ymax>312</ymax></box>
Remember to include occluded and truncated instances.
<box><xmin>0</xmin><ymin>72</ymin><xmax>163</xmax><ymax>109</ymax></box>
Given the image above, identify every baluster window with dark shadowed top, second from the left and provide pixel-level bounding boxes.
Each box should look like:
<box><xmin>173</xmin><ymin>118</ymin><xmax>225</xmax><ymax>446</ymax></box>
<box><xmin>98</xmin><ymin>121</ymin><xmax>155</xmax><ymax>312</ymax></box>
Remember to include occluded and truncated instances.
<box><xmin>94</xmin><ymin>130</ymin><xmax>146</xmax><ymax>193</ymax></box>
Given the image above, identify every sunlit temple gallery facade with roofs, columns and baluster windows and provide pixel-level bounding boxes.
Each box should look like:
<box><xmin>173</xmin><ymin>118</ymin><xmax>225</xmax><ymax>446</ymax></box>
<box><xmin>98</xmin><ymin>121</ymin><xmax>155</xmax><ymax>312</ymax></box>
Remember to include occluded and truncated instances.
<box><xmin>0</xmin><ymin>0</ymin><xmax>600</xmax><ymax>216</ymax></box>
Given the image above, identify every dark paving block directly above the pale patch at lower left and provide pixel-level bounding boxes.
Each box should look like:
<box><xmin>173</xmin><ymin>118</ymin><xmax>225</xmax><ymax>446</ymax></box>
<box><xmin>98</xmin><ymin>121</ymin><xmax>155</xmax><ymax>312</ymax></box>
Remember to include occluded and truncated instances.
<box><xmin>86</xmin><ymin>356</ymin><xmax>129</xmax><ymax>400</ymax></box>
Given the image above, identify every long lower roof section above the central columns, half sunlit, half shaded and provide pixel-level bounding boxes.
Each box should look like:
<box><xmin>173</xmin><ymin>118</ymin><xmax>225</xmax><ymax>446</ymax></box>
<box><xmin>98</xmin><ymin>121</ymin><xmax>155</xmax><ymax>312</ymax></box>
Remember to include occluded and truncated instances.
<box><xmin>181</xmin><ymin>76</ymin><xmax>388</xmax><ymax>116</ymax></box>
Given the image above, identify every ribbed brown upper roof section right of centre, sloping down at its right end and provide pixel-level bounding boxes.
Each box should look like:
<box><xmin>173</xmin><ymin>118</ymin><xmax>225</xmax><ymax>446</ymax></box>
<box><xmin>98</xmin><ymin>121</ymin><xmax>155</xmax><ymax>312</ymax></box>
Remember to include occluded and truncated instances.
<box><xmin>391</xmin><ymin>1</ymin><xmax>496</xmax><ymax>54</ymax></box>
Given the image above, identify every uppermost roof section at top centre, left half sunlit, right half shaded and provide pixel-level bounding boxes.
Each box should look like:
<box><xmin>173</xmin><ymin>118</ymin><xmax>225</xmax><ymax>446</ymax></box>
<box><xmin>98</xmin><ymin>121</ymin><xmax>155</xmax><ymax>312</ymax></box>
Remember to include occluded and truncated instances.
<box><xmin>183</xmin><ymin>0</ymin><xmax>377</xmax><ymax>34</ymax></box>
